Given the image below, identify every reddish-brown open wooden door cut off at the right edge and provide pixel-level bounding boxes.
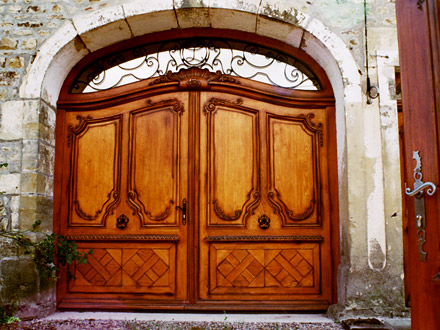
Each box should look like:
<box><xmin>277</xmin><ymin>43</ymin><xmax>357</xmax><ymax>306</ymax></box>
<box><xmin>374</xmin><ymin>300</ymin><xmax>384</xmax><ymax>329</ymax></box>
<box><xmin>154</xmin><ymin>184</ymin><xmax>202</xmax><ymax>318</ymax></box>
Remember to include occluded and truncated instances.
<box><xmin>396</xmin><ymin>0</ymin><xmax>440</xmax><ymax>330</ymax></box>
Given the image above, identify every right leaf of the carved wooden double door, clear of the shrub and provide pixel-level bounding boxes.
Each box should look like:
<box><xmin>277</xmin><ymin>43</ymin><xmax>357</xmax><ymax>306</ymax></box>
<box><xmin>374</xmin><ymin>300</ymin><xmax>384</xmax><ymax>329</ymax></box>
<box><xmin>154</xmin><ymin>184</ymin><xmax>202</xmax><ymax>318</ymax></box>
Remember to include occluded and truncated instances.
<box><xmin>197</xmin><ymin>92</ymin><xmax>332</xmax><ymax>308</ymax></box>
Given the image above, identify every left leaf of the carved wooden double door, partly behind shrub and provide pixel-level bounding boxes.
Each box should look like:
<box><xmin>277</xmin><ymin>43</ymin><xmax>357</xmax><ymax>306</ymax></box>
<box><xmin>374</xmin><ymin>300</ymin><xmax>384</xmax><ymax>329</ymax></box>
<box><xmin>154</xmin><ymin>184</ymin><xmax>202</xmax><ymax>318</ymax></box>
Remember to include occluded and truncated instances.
<box><xmin>58</xmin><ymin>93</ymin><xmax>188</xmax><ymax>307</ymax></box>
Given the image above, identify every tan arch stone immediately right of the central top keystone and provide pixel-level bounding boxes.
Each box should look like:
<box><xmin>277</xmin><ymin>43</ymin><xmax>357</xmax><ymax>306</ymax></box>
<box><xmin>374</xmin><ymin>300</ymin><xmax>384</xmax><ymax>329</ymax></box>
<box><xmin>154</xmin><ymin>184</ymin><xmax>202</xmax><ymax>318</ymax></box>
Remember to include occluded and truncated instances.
<box><xmin>209</xmin><ymin>8</ymin><xmax>257</xmax><ymax>32</ymax></box>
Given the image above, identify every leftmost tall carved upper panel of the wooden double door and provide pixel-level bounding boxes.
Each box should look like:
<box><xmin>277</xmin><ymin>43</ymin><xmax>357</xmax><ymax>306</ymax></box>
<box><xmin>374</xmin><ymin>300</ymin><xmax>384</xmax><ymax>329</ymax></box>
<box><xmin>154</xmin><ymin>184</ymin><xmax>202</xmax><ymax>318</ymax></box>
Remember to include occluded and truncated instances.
<box><xmin>68</xmin><ymin>116</ymin><xmax>122</xmax><ymax>226</ymax></box>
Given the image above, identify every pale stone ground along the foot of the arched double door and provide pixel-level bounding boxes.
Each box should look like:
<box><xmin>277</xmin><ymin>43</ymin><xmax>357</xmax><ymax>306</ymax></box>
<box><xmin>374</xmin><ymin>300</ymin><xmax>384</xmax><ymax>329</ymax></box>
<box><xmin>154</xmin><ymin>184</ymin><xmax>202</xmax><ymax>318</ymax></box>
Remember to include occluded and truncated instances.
<box><xmin>0</xmin><ymin>312</ymin><xmax>409</xmax><ymax>330</ymax></box>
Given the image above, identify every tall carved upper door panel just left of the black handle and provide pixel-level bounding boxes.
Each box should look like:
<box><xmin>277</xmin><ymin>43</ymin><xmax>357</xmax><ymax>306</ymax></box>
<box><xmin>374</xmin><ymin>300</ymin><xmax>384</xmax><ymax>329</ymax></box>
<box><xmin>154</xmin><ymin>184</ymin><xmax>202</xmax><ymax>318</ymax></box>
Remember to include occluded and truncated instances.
<box><xmin>128</xmin><ymin>100</ymin><xmax>187</xmax><ymax>227</ymax></box>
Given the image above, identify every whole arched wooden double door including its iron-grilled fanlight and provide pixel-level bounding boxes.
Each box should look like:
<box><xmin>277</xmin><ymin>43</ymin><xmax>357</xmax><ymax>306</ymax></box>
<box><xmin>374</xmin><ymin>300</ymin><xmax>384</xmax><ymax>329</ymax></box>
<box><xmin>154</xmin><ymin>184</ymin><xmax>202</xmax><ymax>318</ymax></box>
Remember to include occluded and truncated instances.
<box><xmin>54</xmin><ymin>29</ymin><xmax>339</xmax><ymax>310</ymax></box>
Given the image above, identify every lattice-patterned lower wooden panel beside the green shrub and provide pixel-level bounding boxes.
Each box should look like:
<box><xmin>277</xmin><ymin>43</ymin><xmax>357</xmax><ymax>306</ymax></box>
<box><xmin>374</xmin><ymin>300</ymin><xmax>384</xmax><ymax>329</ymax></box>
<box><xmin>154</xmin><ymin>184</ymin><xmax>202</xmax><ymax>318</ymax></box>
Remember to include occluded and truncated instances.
<box><xmin>72</xmin><ymin>245</ymin><xmax>175</xmax><ymax>293</ymax></box>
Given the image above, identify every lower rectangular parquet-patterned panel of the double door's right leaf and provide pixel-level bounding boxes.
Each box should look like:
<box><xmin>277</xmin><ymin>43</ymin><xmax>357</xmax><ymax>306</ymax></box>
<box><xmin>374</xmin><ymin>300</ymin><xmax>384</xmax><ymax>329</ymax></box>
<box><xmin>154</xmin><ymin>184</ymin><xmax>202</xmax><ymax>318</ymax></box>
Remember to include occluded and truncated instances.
<box><xmin>210</xmin><ymin>243</ymin><xmax>320</xmax><ymax>300</ymax></box>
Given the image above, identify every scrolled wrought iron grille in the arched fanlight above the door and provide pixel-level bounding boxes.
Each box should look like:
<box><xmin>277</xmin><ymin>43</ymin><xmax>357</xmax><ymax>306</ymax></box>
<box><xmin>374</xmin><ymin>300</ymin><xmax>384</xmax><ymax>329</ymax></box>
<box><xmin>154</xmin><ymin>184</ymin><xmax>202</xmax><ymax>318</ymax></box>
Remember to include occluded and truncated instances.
<box><xmin>71</xmin><ymin>38</ymin><xmax>320</xmax><ymax>93</ymax></box>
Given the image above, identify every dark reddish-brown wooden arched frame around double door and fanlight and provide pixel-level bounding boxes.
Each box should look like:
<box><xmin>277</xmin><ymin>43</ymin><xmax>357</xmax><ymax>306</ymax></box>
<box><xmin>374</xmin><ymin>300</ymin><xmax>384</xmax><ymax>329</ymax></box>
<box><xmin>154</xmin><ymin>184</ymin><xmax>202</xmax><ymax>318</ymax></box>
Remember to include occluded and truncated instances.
<box><xmin>54</xmin><ymin>29</ymin><xmax>340</xmax><ymax>309</ymax></box>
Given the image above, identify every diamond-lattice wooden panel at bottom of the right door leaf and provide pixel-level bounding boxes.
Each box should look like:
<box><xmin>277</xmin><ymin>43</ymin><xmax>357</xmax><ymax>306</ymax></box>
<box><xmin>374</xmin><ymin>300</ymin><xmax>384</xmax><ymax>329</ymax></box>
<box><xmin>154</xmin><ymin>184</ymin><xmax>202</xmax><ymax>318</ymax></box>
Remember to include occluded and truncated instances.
<box><xmin>211</xmin><ymin>244</ymin><xmax>319</xmax><ymax>292</ymax></box>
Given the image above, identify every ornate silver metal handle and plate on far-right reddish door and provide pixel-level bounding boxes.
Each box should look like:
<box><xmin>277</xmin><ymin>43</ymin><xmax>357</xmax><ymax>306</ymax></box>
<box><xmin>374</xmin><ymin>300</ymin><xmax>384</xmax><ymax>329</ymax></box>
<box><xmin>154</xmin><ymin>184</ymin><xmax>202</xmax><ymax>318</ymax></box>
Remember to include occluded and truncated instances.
<box><xmin>405</xmin><ymin>151</ymin><xmax>436</xmax><ymax>261</ymax></box>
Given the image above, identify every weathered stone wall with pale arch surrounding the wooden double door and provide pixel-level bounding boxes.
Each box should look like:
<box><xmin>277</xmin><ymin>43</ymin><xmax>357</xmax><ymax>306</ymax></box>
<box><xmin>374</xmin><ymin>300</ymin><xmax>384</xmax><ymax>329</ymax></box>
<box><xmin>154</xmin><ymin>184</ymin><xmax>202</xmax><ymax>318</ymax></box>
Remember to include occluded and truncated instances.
<box><xmin>0</xmin><ymin>0</ymin><xmax>405</xmax><ymax>315</ymax></box>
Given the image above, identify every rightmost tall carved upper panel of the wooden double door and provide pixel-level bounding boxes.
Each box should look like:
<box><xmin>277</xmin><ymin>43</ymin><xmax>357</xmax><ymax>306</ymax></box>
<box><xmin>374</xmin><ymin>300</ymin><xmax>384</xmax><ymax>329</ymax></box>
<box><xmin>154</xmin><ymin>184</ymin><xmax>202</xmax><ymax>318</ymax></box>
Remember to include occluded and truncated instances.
<box><xmin>268</xmin><ymin>113</ymin><xmax>322</xmax><ymax>226</ymax></box>
